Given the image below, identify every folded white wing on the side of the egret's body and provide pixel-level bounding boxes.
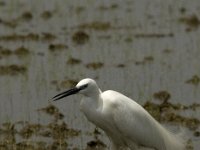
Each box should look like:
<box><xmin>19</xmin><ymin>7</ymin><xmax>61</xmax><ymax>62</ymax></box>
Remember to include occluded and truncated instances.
<box><xmin>101</xmin><ymin>91</ymin><xmax>165</xmax><ymax>150</ymax></box>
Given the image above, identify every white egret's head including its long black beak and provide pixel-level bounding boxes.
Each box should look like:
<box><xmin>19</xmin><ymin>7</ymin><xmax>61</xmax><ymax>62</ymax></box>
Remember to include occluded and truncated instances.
<box><xmin>53</xmin><ymin>78</ymin><xmax>101</xmax><ymax>101</ymax></box>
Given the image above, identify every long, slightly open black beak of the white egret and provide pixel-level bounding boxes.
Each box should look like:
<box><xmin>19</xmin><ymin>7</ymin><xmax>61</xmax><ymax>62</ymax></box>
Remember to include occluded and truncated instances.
<box><xmin>52</xmin><ymin>87</ymin><xmax>81</xmax><ymax>101</ymax></box>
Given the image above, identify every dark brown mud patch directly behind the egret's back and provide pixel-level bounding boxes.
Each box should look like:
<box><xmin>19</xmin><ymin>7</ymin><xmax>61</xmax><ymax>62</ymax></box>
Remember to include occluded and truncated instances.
<box><xmin>143</xmin><ymin>102</ymin><xmax>200</xmax><ymax>131</ymax></box>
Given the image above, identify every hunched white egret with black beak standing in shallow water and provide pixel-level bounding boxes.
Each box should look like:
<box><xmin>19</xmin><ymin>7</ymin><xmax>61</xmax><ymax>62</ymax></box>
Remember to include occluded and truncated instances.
<box><xmin>53</xmin><ymin>78</ymin><xmax>184</xmax><ymax>150</ymax></box>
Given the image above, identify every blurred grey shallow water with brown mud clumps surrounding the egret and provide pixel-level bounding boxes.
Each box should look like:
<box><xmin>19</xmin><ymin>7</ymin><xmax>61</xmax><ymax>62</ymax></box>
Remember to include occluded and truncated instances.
<box><xmin>0</xmin><ymin>0</ymin><xmax>200</xmax><ymax>150</ymax></box>
